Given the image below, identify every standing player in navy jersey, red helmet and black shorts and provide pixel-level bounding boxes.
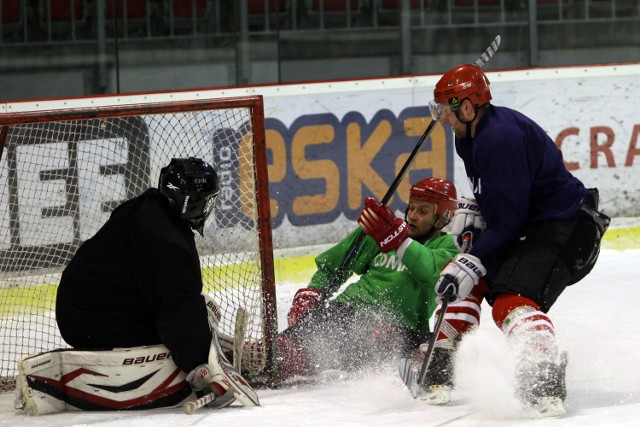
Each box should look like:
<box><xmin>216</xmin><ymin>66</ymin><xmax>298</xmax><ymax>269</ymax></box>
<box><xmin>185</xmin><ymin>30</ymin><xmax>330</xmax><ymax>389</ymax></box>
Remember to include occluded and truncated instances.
<box><xmin>427</xmin><ymin>64</ymin><xmax>609</xmax><ymax>416</ymax></box>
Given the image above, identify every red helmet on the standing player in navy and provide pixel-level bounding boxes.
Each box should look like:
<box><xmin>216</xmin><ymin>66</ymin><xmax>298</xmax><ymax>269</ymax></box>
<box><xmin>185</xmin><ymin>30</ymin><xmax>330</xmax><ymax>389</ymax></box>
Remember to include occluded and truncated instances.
<box><xmin>433</xmin><ymin>64</ymin><xmax>491</xmax><ymax>109</ymax></box>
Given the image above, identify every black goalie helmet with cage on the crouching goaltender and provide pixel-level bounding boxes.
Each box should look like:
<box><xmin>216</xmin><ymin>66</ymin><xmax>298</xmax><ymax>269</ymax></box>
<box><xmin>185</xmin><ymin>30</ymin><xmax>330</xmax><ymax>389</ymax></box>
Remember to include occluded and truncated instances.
<box><xmin>158</xmin><ymin>157</ymin><xmax>220</xmax><ymax>235</ymax></box>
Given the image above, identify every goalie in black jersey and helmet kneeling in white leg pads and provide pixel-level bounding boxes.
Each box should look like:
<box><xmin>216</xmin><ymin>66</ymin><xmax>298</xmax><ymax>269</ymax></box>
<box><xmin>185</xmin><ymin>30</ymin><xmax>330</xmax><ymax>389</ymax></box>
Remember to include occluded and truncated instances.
<box><xmin>16</xmin><ymin>158</ymin><xmax>258</xmax><ymax>414</ymax></box>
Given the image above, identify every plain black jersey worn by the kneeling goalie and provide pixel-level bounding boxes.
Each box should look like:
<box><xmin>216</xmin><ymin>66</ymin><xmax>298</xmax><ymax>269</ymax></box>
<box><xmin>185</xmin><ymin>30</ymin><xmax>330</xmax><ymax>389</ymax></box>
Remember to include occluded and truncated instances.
<box><xmin>56</xmin><ymin>189</ymin><xmax>211</xmax><ymax>372</ymax></box>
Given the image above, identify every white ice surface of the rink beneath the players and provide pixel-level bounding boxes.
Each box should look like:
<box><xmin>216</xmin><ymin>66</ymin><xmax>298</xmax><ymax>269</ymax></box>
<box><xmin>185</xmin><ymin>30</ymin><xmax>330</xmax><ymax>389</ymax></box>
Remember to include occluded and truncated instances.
<box><xmin>0</xmin><ymin>249</ymin><xmax>640</xmax><ymax>427</ymax></box>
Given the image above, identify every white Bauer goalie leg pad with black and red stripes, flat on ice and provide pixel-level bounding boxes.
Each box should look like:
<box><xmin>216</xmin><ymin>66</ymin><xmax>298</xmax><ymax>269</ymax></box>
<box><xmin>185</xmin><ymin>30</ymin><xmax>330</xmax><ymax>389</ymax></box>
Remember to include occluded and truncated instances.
<box><xmin>16</xmin><ymin>345</ymin><xmax>194</xmax><ymax>415</ymax></box>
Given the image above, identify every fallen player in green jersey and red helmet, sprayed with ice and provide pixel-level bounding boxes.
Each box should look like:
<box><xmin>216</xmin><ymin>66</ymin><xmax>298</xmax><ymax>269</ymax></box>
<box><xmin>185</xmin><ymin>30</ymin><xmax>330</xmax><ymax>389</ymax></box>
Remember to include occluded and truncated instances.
<box><xmin>278</xmin><ymin>178</ymin><xmax>458</xmax><ymax>380</ymax></box>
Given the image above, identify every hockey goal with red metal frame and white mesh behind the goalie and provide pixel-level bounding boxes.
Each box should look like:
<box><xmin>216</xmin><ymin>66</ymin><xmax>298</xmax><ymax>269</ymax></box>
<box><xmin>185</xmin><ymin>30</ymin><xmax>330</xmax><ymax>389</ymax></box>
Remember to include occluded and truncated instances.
<box><xmin>0</xmin><ymin>96</ymin><xmax>277</xmax><ymax>389</ymax></box>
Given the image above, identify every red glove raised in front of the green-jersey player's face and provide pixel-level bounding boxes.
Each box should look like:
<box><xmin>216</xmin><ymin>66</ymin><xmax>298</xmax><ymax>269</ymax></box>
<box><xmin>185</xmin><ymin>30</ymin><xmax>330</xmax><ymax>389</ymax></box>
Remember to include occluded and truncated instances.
<box><xmin>358</xmin><ymin>197</ymin><xmax>409</xmax><ymax>253</ymax></box>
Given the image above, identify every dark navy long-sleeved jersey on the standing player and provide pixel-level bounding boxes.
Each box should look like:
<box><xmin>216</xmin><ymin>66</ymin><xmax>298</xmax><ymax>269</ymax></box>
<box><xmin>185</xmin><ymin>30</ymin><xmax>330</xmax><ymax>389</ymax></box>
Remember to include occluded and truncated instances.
<box><xmin>455</xmin><ymin>105</ymin><xmax>588</xmax><ymax>279</ymax></box>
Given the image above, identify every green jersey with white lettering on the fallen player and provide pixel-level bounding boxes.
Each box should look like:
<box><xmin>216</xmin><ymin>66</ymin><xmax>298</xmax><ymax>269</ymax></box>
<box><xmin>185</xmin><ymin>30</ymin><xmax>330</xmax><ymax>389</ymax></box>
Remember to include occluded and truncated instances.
<box><xmin>309</xmin><ymin>229</ymin><xmax>459</xmax><ymax>334</ymax></box>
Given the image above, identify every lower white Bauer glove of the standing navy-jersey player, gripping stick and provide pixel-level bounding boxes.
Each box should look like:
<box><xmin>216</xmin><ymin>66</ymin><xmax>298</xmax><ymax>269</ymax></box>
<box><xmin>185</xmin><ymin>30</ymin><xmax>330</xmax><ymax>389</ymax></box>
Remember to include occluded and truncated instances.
<box><xmin>436</xmin><ymin>254</ymin><xmax>487</xmax><ymax>303</ymax></box>
